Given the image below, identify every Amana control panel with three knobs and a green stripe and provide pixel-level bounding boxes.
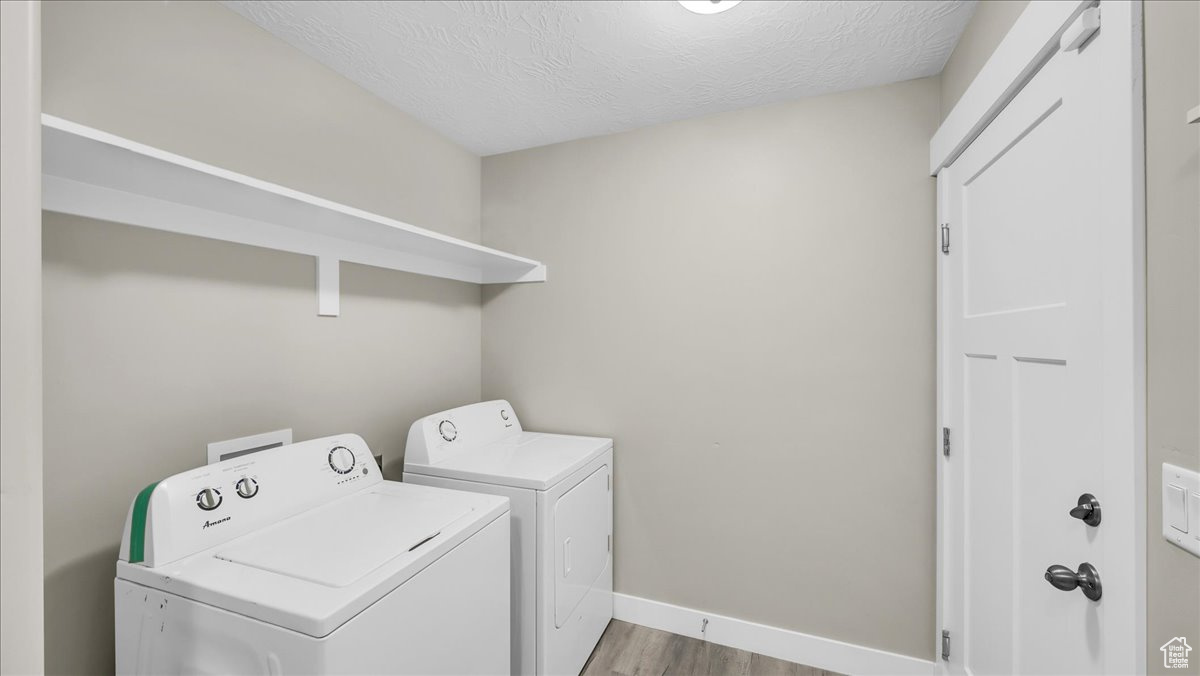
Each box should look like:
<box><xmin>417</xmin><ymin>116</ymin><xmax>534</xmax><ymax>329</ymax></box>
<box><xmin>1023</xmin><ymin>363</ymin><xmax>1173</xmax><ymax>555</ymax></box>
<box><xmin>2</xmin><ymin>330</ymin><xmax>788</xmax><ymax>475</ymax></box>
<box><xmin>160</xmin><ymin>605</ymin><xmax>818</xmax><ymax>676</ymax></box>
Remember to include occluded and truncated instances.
<box><xmin>120</xmin><ymin>435</ymin><xmax>383</xmax><ymax>568</ymax></box>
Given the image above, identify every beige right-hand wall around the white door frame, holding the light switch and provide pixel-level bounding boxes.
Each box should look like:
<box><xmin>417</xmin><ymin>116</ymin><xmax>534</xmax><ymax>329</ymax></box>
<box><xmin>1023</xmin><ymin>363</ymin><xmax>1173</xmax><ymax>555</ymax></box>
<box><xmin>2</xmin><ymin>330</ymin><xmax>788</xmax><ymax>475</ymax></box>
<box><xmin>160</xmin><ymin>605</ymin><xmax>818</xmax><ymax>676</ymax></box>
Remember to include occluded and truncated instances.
<box><xmin>942</xmin><ymin>0</ymin><xmax>1200</xmax><ymax>674</ymax></box>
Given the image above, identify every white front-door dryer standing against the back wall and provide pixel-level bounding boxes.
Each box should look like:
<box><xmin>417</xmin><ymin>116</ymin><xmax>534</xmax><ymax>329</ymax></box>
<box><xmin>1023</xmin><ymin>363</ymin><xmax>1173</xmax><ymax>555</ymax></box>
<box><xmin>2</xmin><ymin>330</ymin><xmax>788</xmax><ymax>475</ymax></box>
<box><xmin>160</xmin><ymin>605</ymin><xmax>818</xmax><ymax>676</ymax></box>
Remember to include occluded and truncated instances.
<box><xmin>403</xmin><ymin>400</ymin><xmax>612</xmax><ymax>675</ymax></box>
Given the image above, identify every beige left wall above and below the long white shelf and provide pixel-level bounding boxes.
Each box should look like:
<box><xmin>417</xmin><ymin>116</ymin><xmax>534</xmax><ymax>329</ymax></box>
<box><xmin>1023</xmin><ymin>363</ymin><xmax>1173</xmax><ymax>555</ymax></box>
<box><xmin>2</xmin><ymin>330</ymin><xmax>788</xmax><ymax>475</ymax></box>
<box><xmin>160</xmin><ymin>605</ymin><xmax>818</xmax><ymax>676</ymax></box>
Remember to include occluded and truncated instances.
<box><xmin>41</xmin><ymin>2</ymin><xmax>480</xmax><ymax>674</ymax></box>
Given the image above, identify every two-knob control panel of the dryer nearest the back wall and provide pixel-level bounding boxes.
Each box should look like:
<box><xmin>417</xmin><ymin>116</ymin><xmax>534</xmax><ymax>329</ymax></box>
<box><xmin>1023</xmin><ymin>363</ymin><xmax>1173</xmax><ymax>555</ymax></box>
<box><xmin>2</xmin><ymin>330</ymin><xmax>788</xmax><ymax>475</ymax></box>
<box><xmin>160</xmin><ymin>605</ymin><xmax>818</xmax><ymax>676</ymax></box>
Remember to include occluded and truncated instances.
<box><xmin>404</xmin><ymin>399</ymin><xmax>521</xmax><ymax>465</ymax></box>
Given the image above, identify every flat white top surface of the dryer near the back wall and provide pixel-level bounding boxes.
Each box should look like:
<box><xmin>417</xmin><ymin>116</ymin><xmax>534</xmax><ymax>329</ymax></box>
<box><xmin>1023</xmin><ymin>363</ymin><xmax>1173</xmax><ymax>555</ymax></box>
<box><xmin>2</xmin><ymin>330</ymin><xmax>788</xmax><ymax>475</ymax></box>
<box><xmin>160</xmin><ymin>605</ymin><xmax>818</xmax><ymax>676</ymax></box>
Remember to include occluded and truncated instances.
<box><xmin>404</xmin><ymin>432</ymin><xmax>612</xmax><ymax>491</ymax></box>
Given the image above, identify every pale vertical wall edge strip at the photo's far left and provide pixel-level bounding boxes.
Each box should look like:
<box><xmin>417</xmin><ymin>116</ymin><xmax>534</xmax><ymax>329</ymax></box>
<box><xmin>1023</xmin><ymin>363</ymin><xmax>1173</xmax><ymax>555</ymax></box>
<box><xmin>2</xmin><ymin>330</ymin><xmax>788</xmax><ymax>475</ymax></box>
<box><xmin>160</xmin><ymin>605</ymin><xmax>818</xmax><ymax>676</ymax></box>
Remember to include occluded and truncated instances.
<box><xmin>0</xmin><ymin>1</ymin><xmax>42</xmax><ymax>675</ymax></box>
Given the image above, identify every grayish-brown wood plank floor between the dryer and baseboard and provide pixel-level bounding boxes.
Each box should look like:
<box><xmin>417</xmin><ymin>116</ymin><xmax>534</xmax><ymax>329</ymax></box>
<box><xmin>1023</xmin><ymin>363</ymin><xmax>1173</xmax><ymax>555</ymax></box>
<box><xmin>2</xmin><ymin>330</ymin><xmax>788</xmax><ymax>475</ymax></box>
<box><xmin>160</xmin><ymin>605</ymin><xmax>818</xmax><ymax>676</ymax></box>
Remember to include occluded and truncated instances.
<box><xmin>583</xmin><ymin>620</ymin><xmax>836</xmax><ymax>676</ymax></box>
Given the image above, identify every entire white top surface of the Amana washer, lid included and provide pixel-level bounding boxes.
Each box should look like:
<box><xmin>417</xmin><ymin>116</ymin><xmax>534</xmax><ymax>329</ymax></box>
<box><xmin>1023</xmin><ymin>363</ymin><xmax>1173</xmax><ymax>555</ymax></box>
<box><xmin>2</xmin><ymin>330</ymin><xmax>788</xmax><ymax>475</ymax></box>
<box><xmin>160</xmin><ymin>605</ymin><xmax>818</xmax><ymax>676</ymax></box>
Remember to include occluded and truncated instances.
<box><xmin>116</xmin><ymin>481</ymin><xmax>509</xmax><ymax>638</ymax></box>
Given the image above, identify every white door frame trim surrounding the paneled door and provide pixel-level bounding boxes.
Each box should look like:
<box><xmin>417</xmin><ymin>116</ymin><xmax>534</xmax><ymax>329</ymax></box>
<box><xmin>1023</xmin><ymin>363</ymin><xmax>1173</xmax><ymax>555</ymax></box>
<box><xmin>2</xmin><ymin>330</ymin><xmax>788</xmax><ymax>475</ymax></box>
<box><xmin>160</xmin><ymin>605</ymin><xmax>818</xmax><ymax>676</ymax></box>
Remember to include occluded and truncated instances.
<box><xmin>929</xmin><ymin>0</ymin><xmax>1146</xmax><ymax>672</ymax></box>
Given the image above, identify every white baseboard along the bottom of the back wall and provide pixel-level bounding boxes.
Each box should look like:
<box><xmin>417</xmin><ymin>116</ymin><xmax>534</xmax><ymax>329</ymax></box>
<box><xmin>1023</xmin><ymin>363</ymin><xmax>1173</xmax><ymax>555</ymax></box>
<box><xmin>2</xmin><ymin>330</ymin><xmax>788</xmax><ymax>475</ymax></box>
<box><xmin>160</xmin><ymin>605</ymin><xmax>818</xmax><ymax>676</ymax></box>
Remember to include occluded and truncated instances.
<box><xmin>613</xmin><ymin>594</ymin><xmax>942</xmax><ymax>676</ymax></box>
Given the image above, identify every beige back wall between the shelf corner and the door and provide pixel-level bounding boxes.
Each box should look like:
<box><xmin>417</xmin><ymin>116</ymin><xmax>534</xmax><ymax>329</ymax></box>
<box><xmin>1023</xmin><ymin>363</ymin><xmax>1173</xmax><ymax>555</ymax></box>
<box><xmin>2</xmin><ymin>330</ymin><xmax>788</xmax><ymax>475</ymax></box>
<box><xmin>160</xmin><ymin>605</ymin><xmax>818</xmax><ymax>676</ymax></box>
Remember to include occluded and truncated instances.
<box><xmin>484</xmin><ymin>79</ymin><xmax>938</xmax><ymax>659</ymax></box>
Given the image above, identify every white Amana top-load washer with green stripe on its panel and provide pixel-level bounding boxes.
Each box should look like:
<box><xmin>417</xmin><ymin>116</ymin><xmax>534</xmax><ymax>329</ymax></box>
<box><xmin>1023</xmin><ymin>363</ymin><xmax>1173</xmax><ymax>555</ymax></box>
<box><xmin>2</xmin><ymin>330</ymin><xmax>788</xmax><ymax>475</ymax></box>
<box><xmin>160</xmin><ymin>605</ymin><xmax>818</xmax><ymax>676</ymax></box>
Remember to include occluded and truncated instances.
<box><xmin>115</xmin><ymin>435</ymin><xmax>510</xmax><ymax>675</ymax></box>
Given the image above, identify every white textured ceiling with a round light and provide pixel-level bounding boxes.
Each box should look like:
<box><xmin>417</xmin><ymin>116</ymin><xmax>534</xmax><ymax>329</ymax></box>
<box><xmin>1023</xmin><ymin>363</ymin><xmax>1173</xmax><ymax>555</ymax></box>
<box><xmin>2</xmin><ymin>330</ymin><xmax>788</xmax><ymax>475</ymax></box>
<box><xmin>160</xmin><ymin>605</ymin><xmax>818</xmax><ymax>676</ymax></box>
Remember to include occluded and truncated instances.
<box><xmin>226</xmin><ymin>0</ymin><xmax>974</xmax><ymax>155</ymax></box>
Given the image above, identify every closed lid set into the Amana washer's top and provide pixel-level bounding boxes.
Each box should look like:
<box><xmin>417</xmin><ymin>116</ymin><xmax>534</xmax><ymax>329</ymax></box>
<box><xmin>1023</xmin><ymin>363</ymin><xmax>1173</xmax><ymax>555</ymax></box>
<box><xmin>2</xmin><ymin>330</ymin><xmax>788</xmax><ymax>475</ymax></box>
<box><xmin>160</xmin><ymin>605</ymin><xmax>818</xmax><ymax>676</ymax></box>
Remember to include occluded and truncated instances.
<box><xmin>214</xmin><ymin>492</ymin><xmax>472</xmax><ymax>587</ymax></box>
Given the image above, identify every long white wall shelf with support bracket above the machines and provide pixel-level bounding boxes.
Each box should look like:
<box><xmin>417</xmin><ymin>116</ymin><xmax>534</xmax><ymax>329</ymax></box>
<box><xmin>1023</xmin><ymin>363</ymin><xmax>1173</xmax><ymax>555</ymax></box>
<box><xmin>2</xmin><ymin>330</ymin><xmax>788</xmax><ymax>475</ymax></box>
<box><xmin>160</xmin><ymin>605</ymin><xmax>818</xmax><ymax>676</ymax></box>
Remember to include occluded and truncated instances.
<box><xmin>42</xmin><ymin>114</ymin><xmax>546</xmax><ymax>316</ymax></box>
